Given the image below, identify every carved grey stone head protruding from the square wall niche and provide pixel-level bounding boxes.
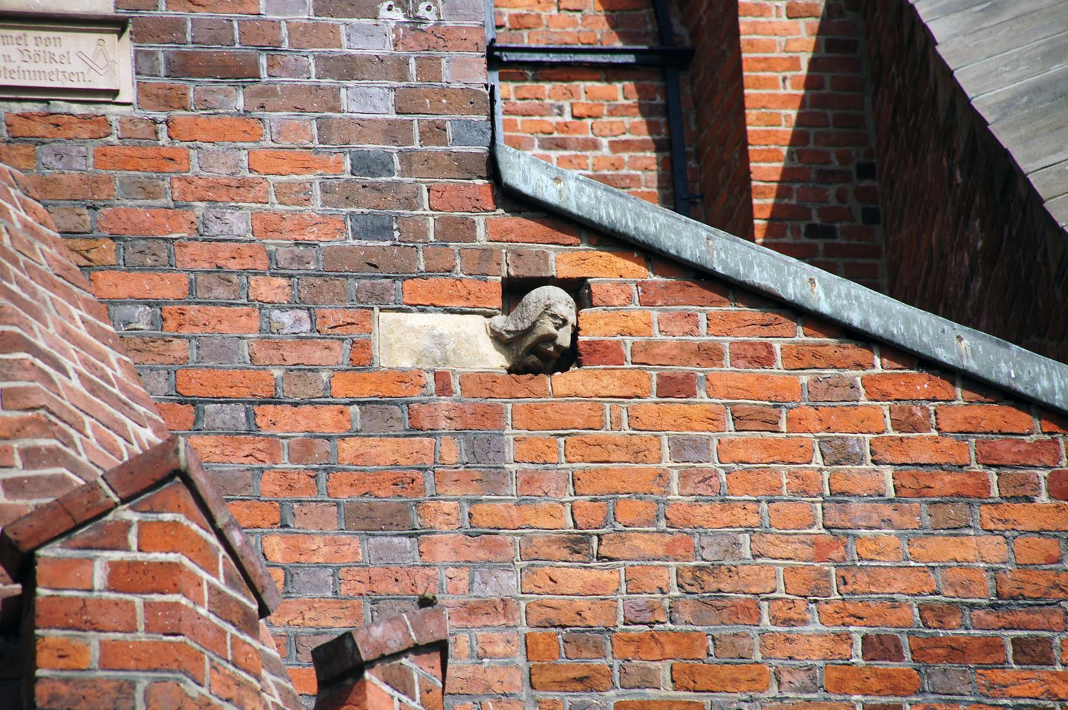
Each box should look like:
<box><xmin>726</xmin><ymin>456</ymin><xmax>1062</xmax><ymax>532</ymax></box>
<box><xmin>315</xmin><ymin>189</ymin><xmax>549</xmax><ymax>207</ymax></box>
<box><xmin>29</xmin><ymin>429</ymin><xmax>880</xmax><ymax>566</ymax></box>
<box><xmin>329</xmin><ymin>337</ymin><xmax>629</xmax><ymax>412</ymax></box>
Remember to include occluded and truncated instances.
<box><xmin>489</xmin><ymin>286</ymin><xmax>576</xmax><ymax>373</ymax></box>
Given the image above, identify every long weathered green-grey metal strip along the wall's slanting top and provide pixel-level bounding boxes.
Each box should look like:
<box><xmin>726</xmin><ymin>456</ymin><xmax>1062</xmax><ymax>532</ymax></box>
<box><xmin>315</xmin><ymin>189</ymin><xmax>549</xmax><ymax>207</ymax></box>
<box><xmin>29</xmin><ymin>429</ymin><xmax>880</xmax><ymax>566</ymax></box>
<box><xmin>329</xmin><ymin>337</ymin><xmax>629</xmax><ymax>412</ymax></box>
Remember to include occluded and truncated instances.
<box><xmin>493</xmin><ymin>140</ymin><xmax>1068</xmax><ymax>413</ymax></box>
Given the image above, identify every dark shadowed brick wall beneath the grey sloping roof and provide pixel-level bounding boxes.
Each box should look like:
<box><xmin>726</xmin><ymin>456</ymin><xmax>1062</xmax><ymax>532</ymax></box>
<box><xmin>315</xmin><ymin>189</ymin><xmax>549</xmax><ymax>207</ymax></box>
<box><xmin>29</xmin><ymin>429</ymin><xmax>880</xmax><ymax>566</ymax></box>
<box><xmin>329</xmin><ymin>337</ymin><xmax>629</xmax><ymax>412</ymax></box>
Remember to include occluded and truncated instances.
<box><xmin>864</xmin><ymin>3</ymin><xmax>1068</xmax><ymax>362</ymax></box>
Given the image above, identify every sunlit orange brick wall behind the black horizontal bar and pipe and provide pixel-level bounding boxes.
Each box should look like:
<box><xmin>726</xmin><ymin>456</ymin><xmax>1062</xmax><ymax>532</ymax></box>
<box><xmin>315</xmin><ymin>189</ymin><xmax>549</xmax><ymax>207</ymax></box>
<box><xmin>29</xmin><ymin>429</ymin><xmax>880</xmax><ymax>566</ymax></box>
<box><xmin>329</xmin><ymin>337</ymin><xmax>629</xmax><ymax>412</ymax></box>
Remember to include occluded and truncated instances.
<box><xmin>496</xmin><ymin>0</ymin><xmax>697</xmax><ymax>206</ymax></box>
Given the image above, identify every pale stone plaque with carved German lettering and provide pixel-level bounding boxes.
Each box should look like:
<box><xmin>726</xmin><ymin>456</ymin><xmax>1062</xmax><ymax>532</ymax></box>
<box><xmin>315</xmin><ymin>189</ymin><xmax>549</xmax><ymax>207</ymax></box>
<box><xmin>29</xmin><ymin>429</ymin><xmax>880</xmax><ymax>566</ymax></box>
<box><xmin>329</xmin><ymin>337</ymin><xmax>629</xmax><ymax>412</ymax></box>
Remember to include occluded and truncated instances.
<box><xmin>0</xmin><ymin>16</ymin><xmax>132</xmax><ymax>102</ymax></box>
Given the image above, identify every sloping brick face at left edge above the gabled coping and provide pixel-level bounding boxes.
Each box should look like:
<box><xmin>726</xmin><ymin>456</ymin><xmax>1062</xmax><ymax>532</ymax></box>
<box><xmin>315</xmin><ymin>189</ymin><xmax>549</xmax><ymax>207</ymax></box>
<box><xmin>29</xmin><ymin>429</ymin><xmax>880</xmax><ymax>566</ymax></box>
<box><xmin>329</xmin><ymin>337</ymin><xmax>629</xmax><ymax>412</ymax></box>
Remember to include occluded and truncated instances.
<box><xmin>0</xmin><ymin>162</ymin><xmax>167</xmax><ymax>526</ymax></box>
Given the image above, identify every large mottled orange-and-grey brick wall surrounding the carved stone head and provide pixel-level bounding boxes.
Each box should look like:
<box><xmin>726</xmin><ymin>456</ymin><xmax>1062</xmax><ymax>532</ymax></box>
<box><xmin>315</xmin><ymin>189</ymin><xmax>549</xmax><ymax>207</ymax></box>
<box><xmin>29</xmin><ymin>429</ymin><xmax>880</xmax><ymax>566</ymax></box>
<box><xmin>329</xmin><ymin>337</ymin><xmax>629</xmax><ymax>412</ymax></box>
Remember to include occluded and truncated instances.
<box><xmin>3</xmin><ymin>0</ymin><xmax>1068</xmax><ymax>710</ymax></box>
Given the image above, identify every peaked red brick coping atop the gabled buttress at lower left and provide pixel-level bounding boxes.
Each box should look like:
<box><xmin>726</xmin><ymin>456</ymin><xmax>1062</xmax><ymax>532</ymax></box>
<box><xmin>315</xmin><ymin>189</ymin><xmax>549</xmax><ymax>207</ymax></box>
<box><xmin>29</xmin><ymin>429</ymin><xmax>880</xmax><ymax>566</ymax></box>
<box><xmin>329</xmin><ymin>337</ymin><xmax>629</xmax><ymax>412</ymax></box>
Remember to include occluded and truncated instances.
<box><xmin>0</xmin><ymin>435</ymin><xmax>282</xmax><ymax>618</ymax></box>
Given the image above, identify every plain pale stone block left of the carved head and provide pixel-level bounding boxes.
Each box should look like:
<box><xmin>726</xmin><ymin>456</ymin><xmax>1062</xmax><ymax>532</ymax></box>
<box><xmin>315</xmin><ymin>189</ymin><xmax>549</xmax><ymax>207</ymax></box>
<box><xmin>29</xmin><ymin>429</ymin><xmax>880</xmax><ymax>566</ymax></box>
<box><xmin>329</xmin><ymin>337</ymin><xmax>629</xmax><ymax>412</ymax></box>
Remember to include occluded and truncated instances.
<box><xmin>378</xmin><ymin>313</ymin><xmax>508</xmax><ymax>369</ymax></box>
